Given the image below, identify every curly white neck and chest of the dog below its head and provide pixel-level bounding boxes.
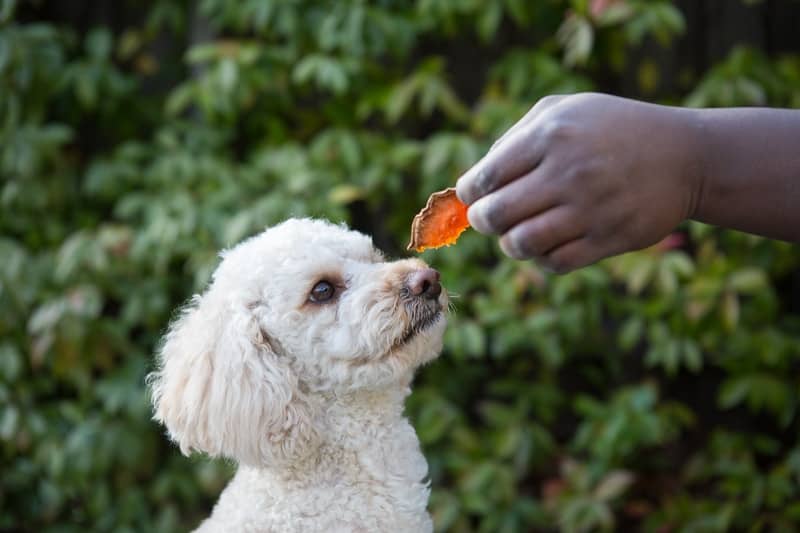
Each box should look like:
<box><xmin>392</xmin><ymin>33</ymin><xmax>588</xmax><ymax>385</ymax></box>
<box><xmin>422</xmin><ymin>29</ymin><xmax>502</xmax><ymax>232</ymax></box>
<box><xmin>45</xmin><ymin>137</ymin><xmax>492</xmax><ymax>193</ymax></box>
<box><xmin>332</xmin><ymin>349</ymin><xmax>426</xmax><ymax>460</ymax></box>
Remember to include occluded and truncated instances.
<box><xmin>203</xmin><ymin>385</ymin><xmax>432</xmax><ymax>532</ymax></box>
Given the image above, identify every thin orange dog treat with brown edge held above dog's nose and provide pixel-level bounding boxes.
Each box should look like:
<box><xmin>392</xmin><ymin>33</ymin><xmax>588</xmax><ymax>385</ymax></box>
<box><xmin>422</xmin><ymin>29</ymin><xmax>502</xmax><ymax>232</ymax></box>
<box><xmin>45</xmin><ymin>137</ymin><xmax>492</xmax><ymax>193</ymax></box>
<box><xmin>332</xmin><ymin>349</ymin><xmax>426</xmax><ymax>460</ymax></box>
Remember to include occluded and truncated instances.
<box><xmin>408</xmin><ymin>187</ymin><xmax>469</xmax><ymax>252</ymax></box>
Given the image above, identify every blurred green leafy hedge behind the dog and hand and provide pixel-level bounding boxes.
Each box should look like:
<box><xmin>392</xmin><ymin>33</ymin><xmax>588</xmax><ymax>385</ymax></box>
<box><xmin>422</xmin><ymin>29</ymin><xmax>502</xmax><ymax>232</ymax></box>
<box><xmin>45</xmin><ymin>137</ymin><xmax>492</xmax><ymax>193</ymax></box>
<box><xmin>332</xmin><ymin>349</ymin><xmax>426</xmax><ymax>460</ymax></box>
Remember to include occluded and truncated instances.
<box><xmin>0</xmin><ymin>0</ymin><xmax>800</xmax><ymax>533</ymax></box>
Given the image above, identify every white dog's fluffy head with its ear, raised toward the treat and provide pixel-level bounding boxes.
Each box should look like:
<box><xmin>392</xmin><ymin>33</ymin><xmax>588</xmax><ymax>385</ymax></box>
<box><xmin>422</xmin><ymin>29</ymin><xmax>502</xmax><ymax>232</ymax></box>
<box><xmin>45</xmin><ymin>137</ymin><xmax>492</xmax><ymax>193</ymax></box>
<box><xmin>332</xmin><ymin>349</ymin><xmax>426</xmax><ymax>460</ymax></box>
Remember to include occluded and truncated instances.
<box><xmin>149</xmin><ymin>219</ymin><xmax>447</xmax><ymax>465</ymax></box>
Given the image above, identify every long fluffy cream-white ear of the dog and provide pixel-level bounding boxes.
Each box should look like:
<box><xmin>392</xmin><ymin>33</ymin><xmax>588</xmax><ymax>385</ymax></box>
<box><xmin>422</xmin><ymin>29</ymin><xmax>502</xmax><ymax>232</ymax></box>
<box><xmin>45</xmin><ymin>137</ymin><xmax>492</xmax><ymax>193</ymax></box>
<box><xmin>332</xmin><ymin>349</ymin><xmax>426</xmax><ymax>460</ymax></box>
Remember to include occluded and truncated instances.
<box><xmin>148</xmin><ymin>290</ymin><xmax>319</xmax><ymax>466</ymax></box>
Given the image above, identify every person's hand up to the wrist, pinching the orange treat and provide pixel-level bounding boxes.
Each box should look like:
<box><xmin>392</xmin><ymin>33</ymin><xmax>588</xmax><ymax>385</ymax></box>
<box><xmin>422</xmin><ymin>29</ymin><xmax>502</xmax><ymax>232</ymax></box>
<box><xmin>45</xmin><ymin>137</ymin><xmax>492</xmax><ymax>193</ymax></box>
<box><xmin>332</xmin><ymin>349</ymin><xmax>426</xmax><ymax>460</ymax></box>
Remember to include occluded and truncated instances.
<box><xmin>456</xmin><ymin>93</ymin><xmax>700</xmax><ymax>273</ymax></box>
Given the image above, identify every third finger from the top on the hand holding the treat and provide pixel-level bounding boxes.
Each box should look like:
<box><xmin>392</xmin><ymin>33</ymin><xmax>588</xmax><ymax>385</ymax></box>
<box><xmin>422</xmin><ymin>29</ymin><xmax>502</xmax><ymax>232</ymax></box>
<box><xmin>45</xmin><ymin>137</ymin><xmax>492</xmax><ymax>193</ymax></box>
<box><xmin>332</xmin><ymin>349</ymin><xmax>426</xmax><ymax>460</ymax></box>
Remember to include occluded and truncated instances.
<box><xmin>500</xmin><ymin>206</ymin><xmax>586</xmax><ymax>261</ymax></box>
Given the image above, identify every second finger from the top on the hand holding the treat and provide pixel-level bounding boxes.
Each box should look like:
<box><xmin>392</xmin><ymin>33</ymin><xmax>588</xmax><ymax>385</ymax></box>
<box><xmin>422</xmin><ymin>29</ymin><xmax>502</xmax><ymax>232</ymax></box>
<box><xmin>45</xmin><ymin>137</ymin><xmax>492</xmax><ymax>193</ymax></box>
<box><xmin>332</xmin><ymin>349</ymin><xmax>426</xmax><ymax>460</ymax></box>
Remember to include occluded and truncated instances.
<box><xmin>467</xmin><ymin>163</ymin><xmax>557</xmax><ymax>235</ymax></box>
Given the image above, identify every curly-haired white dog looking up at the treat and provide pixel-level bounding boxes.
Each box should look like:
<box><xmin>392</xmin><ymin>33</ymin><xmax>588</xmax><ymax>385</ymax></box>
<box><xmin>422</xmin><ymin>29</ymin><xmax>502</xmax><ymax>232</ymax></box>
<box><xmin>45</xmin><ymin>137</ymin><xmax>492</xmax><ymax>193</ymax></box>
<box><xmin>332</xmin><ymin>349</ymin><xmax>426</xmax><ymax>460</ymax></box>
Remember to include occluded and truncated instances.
<box><xmin>149</xmin><ymin>219</ymin><xmax>448</xmax><ymax>533</ymax></box>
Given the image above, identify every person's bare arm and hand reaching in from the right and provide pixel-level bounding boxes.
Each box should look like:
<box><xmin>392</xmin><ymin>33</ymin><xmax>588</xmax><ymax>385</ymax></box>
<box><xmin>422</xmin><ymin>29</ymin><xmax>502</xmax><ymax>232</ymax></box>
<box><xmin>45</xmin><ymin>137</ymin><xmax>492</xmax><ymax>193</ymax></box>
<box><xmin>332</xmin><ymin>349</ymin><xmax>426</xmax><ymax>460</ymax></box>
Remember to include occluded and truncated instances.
<box><xmin>457</xmin><ymin>93</ymin><xmax>800</xmax><ymax>272</ymax></box>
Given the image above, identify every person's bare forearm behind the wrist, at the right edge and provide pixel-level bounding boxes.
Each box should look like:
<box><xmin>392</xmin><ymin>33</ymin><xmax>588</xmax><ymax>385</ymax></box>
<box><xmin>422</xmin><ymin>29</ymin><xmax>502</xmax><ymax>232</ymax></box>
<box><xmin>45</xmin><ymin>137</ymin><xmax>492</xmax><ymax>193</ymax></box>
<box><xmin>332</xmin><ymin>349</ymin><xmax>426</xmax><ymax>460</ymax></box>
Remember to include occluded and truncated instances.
<box><xmin>691</xmin><ymin>108</ymin><xmax>800</xmax><ymax>242</ymax></box>
